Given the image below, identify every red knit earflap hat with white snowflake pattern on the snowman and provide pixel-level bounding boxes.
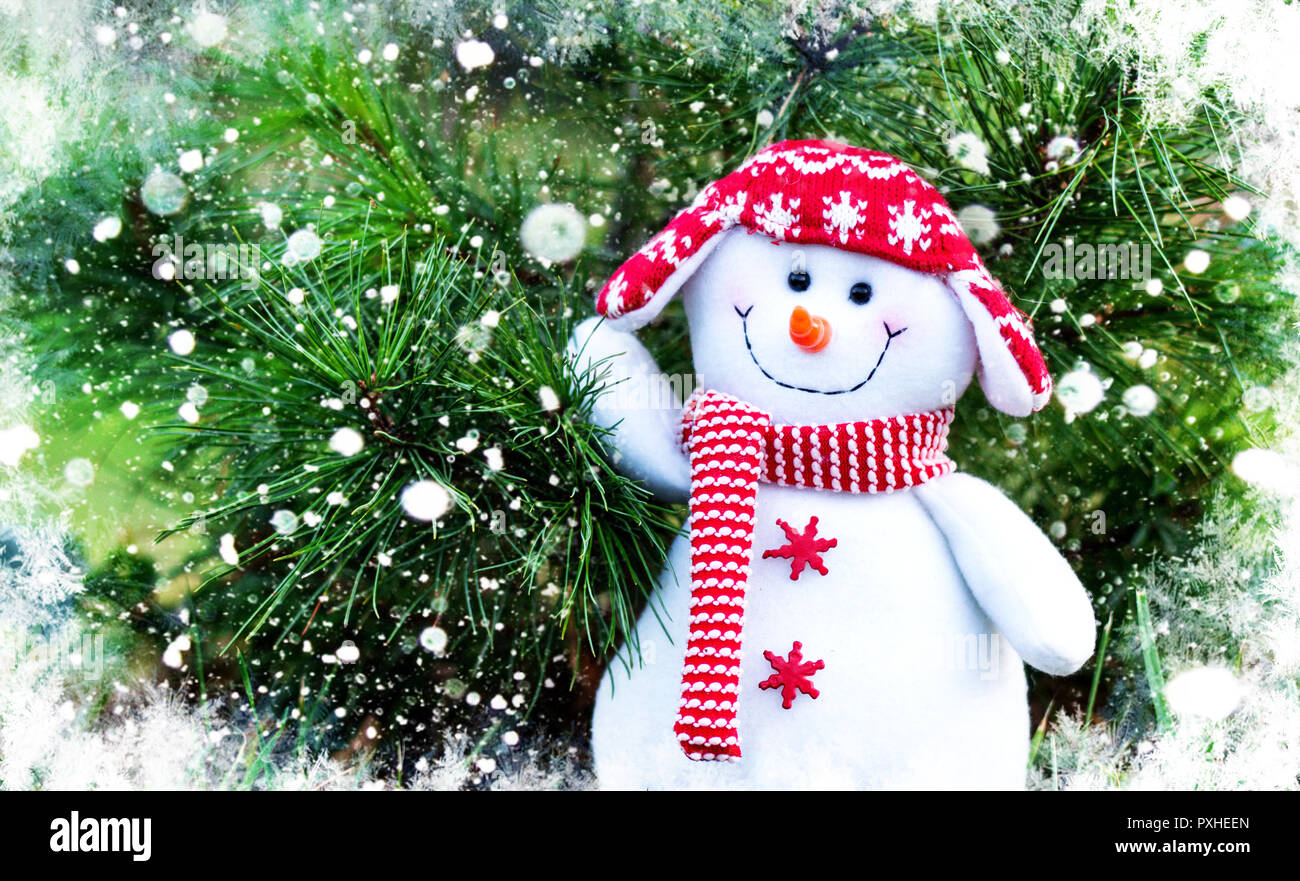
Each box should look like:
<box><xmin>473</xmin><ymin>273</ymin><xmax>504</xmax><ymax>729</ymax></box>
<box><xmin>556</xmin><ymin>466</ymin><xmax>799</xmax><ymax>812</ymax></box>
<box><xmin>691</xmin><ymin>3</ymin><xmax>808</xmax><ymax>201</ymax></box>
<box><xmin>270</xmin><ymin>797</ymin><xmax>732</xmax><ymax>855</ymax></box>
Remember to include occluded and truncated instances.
<box><xmin>595</xmin><ymin>140</ymin><xmax>1052</xmax><ymax>416</ymax></box>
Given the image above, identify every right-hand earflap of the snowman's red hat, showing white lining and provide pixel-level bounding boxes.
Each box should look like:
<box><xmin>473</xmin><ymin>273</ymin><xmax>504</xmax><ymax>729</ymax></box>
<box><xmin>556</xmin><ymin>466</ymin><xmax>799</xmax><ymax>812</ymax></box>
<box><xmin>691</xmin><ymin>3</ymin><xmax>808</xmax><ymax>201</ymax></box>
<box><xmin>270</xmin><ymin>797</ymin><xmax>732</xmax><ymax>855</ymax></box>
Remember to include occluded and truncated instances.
<box><xmin>944</xmin><ymin>270</ymin><xmax>1050</xmax><ymax>416</ymax></box>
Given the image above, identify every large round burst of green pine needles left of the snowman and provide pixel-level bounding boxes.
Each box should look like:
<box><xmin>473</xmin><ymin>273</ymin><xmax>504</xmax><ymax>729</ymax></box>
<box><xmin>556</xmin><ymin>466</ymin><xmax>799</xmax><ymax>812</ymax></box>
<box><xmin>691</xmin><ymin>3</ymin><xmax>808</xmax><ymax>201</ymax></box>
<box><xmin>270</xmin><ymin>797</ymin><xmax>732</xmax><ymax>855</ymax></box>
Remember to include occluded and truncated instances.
<box><xmin>154</xmin><ymin>226</ymin><xmax>670</xmax><ymax>743</ymax></box>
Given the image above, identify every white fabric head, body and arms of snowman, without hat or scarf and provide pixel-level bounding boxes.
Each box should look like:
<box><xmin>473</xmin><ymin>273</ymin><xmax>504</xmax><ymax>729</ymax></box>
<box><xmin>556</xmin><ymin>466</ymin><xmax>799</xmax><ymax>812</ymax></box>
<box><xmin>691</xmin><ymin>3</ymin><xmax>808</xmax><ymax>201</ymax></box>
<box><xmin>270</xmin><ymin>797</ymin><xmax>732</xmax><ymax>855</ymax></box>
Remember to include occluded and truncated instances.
<box><xmin>569</xmin><ymin>230</ymin><xmax>1096</xmax><ymax>789</ymax></box>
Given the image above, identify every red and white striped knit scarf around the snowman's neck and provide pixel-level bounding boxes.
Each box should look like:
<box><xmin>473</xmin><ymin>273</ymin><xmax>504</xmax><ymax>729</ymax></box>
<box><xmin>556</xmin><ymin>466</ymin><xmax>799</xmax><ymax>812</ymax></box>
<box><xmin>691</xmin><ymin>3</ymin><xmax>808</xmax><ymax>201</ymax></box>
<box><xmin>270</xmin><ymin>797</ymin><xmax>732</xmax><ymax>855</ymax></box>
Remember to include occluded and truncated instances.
<box><xmin>673</xmin><ymin>390</ymin><xmax>954</xmax><ymax>760</ymax></box>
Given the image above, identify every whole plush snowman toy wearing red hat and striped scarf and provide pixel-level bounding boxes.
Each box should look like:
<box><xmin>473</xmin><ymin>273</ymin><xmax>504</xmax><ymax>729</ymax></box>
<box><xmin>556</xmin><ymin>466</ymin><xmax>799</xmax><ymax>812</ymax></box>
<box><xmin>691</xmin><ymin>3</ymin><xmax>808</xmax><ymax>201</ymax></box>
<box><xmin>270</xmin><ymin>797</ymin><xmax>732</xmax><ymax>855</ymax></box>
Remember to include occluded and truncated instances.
<box><xmin>571</xmin><ymin>142</ymin><xmax>1096</xmax><ymax>789</ymax></box>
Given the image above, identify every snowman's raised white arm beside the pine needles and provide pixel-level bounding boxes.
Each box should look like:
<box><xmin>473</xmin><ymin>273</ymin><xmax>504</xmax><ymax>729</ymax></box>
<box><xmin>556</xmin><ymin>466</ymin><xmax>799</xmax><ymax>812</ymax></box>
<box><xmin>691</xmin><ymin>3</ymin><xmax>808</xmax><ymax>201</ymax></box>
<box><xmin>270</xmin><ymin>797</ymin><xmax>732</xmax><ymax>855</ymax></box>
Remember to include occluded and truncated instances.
<box><xmin>568</xmin><ymin>318</ymin><xmax>690</xmax><ymax>502</ymax></box>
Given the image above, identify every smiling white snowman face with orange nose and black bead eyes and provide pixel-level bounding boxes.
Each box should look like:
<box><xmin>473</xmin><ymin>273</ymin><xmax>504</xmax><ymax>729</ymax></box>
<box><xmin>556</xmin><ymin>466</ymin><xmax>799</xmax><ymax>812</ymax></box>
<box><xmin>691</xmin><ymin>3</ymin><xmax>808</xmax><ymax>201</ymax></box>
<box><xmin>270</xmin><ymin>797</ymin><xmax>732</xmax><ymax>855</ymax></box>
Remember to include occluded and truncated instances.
<box><xmin>683</xmin><ymin>227</ymin><xmax>976</xmax><ymax>424</ymax></box>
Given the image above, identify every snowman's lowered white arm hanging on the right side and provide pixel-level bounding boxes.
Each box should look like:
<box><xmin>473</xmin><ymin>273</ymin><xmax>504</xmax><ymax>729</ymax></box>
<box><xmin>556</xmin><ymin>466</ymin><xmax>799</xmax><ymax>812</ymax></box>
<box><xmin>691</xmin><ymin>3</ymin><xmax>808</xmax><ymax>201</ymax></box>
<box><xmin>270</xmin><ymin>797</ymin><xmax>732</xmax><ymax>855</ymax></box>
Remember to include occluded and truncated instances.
<box><xmin>913</xmin><ymin>473</ymin><xmax>1097</xmax><ymax>676</ymax></box>
